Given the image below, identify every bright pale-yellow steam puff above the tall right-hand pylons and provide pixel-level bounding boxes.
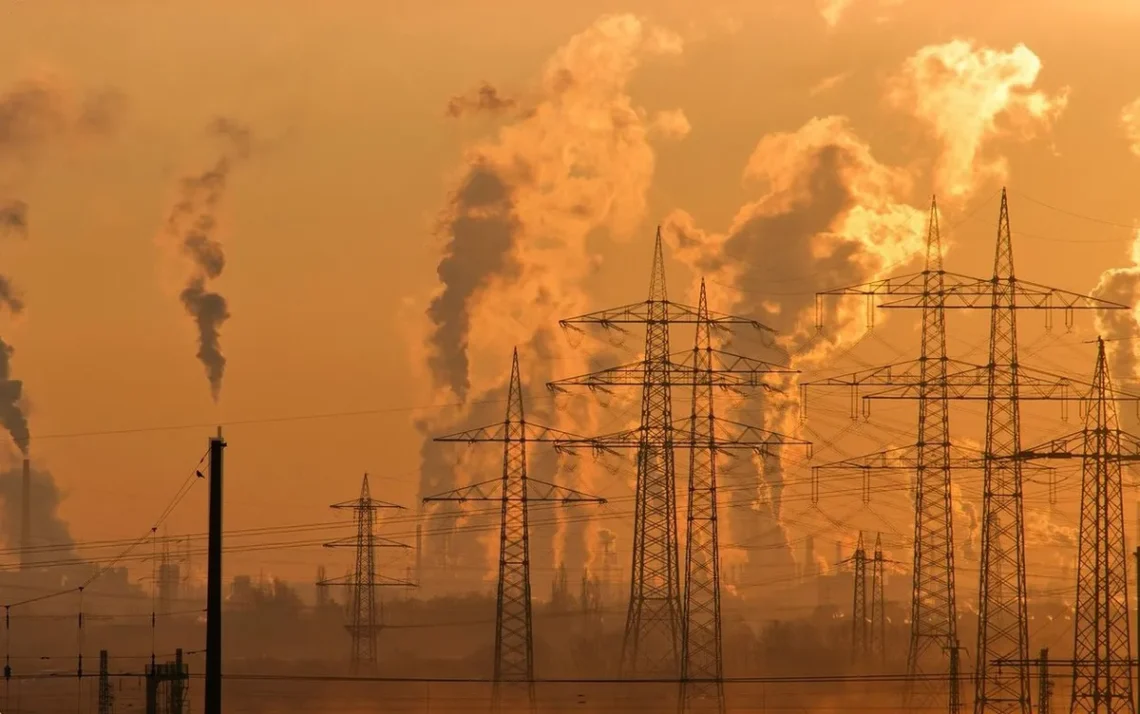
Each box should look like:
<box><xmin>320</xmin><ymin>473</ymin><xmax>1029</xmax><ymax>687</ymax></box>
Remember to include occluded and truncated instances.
<box><xmin>888</xmin><ymin>40</ymin><xmax>1068</xmax><ymax>197</ymax></box>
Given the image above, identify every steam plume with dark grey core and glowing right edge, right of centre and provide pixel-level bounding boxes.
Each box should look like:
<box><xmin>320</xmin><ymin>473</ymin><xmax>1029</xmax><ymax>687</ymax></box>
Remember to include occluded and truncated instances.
<box><xmin>666</xmin><ymin>116</ymin><xmax>925</xmax><ymax>581</ymax></box>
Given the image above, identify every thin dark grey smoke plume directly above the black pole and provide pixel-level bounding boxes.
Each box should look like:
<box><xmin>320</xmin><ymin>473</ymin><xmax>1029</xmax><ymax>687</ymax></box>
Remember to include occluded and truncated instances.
<box><xmin>166</xmin><ymin>117</ymin><xmax>252</xmax><ymax>401</ymax></box>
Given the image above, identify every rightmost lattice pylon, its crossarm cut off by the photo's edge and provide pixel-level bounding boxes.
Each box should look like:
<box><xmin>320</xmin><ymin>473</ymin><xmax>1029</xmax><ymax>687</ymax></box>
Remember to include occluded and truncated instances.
<box><xmin>1019</xmin><ymin>339</ymin><xmax>1140</xmax><ymax>714</ymax></box>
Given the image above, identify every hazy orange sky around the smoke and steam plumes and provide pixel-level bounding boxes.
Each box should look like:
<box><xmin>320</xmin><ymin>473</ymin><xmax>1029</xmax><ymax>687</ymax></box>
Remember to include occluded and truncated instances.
<box><xmin>0</xmin><ymin>0</ymin><xmax>1140</xmax><ymax>593</ymax></box>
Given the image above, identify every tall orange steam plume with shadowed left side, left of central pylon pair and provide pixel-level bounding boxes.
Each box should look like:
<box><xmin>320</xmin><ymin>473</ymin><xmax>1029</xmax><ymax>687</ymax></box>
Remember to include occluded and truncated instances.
<box><xmin>417</xmin><ymin>15</ymin><xmax>687</xmax><ymax>588</ymax></box>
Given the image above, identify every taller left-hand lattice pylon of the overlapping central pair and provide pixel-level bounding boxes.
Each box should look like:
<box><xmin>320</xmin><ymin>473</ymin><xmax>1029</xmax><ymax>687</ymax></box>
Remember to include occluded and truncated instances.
<box><xmin>549</xmin><ymin>228</ymin><xmax>795</xmax><ymax>678</ymax></box>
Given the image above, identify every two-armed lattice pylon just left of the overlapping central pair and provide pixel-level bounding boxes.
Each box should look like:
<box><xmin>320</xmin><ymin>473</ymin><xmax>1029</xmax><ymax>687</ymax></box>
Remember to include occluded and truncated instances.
<box><xmin>424</xmin><ymin>349</ymin><xmax>605</xmax><ymax>712</ymax></box>
